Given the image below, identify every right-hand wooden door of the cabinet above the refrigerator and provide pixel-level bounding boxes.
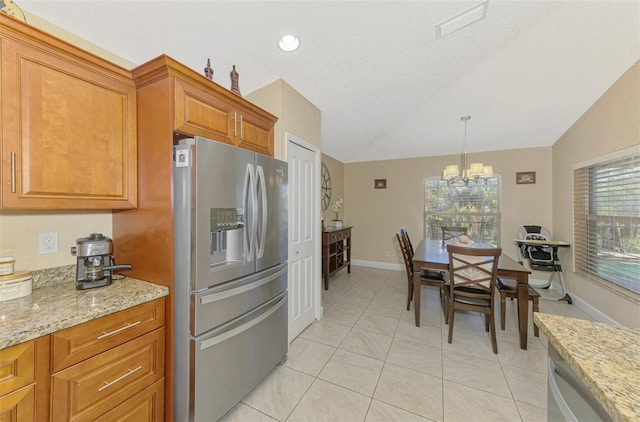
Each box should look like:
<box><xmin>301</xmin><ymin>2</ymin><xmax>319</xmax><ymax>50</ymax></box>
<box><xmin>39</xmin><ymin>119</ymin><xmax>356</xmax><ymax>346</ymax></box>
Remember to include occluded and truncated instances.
<box><xmin>234</xmin><ymin>108</ymin><xmax>275</xmax><ymax>157</ymax></box>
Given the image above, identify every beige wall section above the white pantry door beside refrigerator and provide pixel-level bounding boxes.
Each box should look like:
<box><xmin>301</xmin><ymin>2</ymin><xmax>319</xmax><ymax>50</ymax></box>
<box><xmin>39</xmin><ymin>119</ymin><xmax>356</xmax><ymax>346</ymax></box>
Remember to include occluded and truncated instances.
<box><xmin>245</xmin><ymin>79</ymin><xmax>322</xmax><ymax>160</ymax></box>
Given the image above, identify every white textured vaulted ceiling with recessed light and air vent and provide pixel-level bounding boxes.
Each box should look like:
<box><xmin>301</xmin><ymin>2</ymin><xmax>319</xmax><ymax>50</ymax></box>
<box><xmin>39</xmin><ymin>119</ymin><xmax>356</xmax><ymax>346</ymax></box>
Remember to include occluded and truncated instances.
<box><xmin>16</xmin><ymin>0</ymin><xmax>640</xmax><ymax>162</ymax></box>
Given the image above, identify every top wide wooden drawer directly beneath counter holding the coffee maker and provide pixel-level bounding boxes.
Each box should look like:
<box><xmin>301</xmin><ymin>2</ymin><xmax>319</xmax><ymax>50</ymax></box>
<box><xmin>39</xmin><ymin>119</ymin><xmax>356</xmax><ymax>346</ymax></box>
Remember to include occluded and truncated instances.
<box><xmin>51</xmin><ymin>298</ymin><xmax>164</xmax><ymax>373</ymax></box>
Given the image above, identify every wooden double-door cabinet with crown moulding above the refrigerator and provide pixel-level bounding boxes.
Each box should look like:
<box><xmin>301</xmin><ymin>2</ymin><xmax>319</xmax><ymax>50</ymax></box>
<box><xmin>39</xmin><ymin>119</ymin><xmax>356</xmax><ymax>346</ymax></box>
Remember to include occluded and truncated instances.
<box><xmin>133</xmin><ymin>55</ymin><xmax>277</xmax><ymax>156</ymax></box>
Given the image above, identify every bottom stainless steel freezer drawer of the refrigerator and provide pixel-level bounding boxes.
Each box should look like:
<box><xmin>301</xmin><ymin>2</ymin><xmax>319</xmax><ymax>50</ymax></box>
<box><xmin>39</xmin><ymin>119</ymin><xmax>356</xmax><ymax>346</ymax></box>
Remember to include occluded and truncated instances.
<box><xmin>190</xmin><ymin>292</ymin><xmax>287</xmax><ymax>421</ymax></box>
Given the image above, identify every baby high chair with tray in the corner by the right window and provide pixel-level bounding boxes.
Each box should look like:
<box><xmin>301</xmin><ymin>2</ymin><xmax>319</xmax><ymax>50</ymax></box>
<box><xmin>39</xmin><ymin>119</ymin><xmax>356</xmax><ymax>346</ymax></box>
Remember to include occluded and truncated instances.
<box><xmin>514</xmin><ymin>225</ymin><xmax>573</xmax><ymax>304</ymax></box>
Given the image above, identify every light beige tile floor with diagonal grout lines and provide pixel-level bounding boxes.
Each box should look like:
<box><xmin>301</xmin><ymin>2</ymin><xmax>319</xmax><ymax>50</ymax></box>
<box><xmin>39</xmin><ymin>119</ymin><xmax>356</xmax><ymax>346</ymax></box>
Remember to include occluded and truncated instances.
<box><xmin>223</xmin><ymin>266</ymin><xmax>589</xmax><ymax>422</ymax></box>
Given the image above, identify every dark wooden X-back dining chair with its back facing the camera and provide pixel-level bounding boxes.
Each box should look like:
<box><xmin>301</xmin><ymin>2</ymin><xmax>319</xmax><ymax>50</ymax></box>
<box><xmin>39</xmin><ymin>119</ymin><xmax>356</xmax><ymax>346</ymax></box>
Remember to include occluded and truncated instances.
<box><xmin>445</xmin><ymin>245</ymin><xmax>502</xmax><ymax>354</ymax></box>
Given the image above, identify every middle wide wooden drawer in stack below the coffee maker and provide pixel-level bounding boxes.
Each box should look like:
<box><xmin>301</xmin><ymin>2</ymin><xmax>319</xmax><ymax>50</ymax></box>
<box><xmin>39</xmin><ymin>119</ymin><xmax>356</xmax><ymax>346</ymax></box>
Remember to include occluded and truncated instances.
<box><xmin>51</xmin><ymin>327</ymin><xmax>165</xmax><ymax>421</ymax></box>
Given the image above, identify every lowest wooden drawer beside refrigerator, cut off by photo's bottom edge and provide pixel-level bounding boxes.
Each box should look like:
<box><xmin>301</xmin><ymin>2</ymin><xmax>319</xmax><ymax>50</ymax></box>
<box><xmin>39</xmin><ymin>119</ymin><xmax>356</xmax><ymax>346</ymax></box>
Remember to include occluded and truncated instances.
<box><xmin>95</xmin><ymin>378</ymin><xmax>164</xmax><ymax>422</ymax></box>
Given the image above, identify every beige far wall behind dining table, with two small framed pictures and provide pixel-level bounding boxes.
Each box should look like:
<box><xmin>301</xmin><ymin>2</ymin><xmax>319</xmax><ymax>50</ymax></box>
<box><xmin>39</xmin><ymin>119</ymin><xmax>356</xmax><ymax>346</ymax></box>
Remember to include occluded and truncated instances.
<box><xmin>344</xmin><ymin>147</ymin><xmax>552</xmax><ymax>265</ymax></box>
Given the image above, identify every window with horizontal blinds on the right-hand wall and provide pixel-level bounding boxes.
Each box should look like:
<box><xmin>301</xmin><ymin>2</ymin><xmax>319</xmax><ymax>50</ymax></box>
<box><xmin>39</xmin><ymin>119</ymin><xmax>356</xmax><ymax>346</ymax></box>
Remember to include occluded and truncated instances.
<box><xmin>573</xmin><ymin>147</ymin><xmax>640</xmax><ymax>300</ymax></box>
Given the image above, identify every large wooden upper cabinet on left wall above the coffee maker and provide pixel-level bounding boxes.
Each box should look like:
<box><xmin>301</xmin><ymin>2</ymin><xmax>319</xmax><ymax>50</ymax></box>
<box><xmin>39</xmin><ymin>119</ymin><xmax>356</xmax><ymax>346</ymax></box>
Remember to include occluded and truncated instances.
<box><xmin>0</xmin><ymin>15</ymin><xmax>137</xmax><ymax>209</ymax></box>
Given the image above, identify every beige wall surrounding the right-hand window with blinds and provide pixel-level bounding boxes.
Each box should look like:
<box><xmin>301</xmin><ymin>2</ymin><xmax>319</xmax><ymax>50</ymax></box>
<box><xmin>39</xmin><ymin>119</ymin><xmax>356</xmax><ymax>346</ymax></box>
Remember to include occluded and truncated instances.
<box><xmin>553</xmin><ymin>62</ymin><xmax>640</xmax><ymax>327</ymax></box>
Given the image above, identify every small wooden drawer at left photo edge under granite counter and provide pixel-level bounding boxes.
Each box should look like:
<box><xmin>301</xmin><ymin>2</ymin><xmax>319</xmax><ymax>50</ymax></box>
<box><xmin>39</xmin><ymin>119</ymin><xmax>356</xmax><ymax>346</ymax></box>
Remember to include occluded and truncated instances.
<box><xmin>0</xmin><ymin>341</ymin><xmax>35</xmax><ymax>396</ymax></box>
